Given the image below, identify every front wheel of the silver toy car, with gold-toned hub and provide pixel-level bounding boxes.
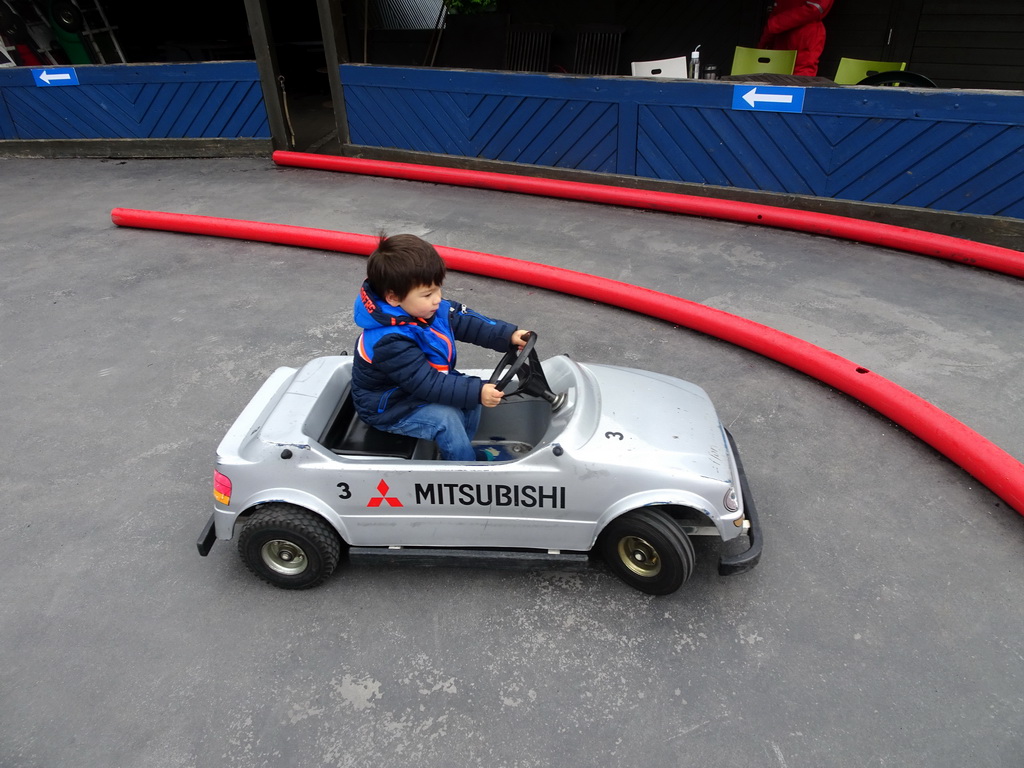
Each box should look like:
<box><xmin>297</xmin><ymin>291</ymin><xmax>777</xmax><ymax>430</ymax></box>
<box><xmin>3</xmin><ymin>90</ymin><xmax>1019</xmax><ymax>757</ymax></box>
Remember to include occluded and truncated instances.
<box><xmin>599</xmin><ymin>509</ymin><xmax>694</xmax><ymax>595</ymax></box>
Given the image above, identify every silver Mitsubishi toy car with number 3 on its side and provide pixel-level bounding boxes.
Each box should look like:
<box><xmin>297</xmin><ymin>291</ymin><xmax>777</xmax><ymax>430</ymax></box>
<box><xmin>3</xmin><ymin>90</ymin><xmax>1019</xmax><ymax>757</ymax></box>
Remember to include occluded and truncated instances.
<box><xmin>198</xmin><ymin>334</ymin><xmax>762</xmax><ymax>595</ymax></box>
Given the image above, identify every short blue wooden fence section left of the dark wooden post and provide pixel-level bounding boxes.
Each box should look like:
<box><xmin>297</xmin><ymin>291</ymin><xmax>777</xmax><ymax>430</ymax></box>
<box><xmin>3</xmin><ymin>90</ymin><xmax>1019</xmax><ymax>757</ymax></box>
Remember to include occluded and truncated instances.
<box><xmin>0</xmin><ymin>61</ymin><xmax>270</xmax><ymax>139</ymax></box>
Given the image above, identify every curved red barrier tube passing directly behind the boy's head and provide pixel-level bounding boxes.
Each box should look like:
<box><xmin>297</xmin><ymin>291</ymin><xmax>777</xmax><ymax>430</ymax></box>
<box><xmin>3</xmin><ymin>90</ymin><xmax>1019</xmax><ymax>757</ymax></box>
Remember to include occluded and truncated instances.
<box><xmin>111</xmin><ymin>208</ymin><xmax>1024</xmax><ymax>515</ymax></box>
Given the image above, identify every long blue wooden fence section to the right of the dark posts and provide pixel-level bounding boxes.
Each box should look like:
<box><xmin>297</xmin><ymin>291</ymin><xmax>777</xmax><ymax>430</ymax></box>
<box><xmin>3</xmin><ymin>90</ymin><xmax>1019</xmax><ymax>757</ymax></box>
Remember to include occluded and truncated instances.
<box><xmin>341</xmin><ymin>65</ymin><xmax>1024</xmax><ymax>218</ymax></box>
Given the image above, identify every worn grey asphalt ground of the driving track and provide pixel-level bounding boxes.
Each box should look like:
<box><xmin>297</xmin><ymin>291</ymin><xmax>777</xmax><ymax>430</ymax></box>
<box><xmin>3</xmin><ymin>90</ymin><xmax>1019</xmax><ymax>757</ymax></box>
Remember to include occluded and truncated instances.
<box><xmin>6</xmin><ymin>159</ymin><xmax>1024</xmax><ymax>768</ymax></box>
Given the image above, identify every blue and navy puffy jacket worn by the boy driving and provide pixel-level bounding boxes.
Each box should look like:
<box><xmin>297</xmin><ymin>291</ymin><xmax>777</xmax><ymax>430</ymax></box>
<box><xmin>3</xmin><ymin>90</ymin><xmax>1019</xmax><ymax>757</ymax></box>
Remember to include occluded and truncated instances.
<box><xmin>352</xmin><ymin>283</ymin><xmax>516</xmax><ymax>429</ymax></box>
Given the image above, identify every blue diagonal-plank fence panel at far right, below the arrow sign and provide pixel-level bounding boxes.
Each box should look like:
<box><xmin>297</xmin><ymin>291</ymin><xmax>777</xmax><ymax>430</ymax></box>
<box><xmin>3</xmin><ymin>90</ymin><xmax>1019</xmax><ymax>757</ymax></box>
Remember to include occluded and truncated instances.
<box><xmin>636</xmin><ymin>106</ymin><xmax>1024</xmax><ymax>218</ymax></box>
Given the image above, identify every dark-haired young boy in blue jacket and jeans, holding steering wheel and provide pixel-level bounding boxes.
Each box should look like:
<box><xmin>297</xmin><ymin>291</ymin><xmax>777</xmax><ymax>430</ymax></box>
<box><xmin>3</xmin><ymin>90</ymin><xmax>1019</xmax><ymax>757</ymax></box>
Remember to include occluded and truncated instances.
<box><xmin>352</xmin><ymin>234</ymin><xmax>529</xmax><ymax>461</ymax></box>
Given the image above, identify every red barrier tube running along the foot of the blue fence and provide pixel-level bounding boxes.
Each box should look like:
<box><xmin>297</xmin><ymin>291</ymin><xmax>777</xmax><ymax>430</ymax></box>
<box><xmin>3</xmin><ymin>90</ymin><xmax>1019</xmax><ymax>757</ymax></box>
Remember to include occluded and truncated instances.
<box><xmin>273</xmin><ymin>151</ymin><xmax>1024</xmax><ymax>278</ymax></box>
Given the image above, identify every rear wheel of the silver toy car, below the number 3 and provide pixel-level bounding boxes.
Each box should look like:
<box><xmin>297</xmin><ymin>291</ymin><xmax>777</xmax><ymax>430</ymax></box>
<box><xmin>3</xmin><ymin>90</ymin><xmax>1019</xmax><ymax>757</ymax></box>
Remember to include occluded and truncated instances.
<box><xmin>239</xmin><ymin>503</ymin><xmax>341</xmax><ymax>590</ymax></box>
